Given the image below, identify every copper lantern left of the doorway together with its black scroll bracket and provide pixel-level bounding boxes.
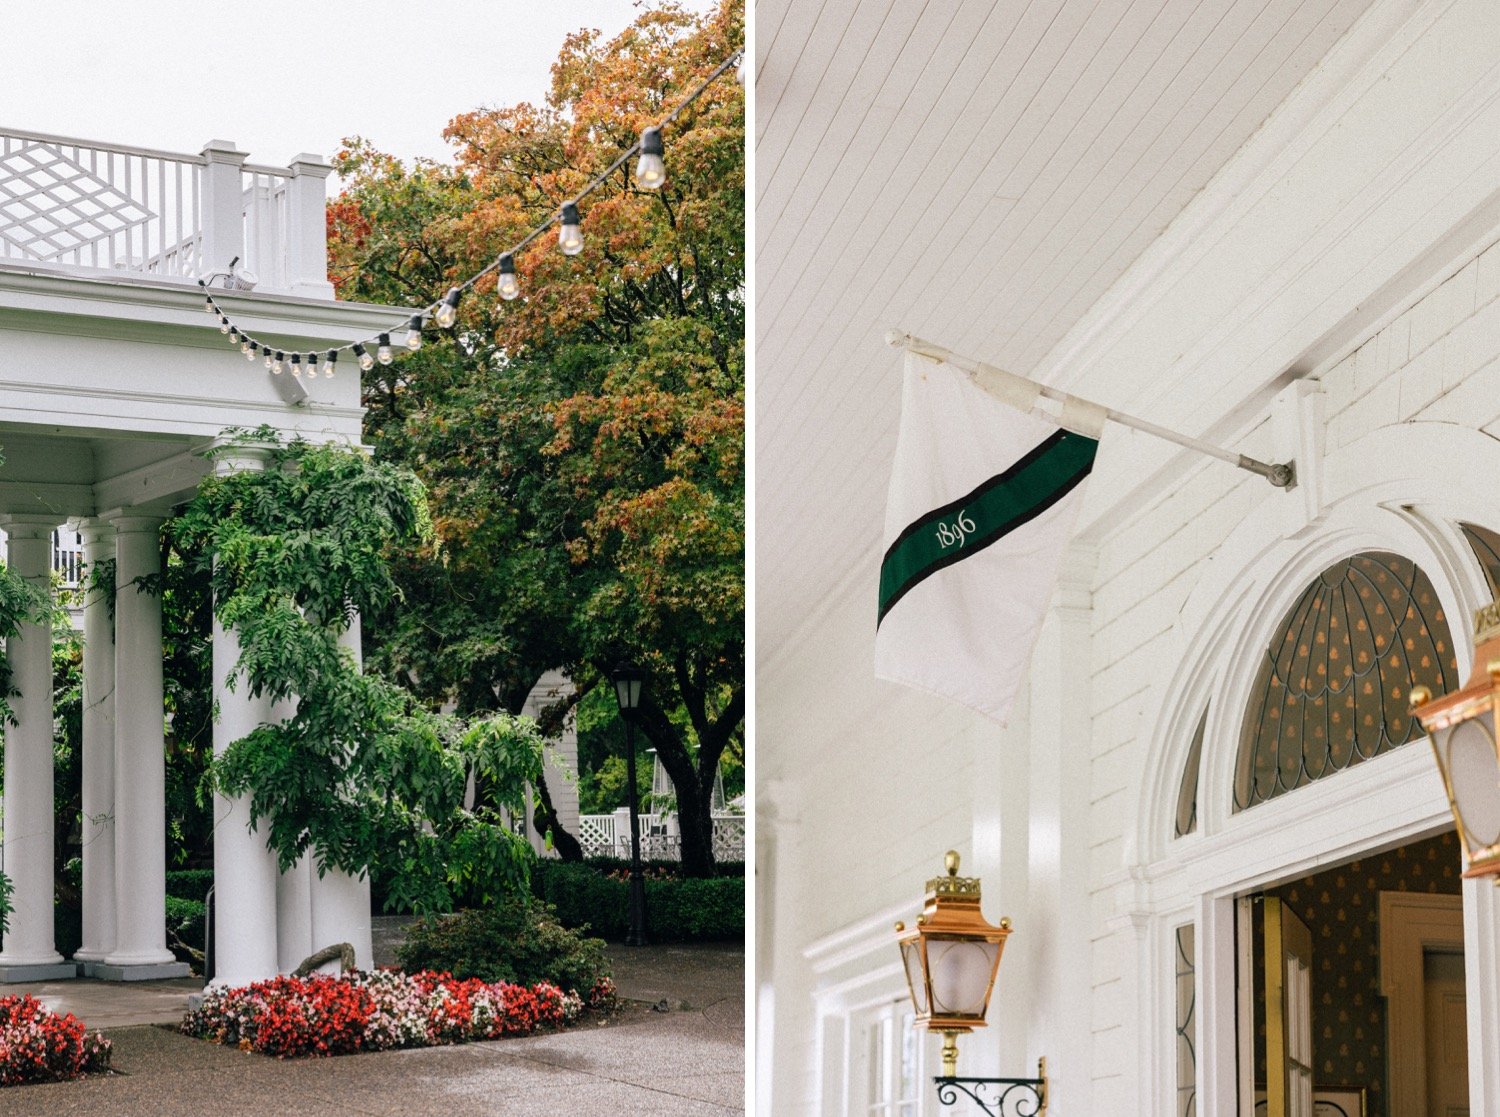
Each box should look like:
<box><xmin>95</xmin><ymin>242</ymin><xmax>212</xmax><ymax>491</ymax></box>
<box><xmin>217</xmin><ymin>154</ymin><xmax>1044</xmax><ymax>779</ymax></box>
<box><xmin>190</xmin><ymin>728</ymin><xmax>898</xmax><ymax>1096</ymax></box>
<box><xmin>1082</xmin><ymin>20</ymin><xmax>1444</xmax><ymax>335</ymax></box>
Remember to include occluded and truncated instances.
<box><xmin>896</xmin><ymin>850</ymin><xmax>1047</xmax><ymax>1117</ymax></box>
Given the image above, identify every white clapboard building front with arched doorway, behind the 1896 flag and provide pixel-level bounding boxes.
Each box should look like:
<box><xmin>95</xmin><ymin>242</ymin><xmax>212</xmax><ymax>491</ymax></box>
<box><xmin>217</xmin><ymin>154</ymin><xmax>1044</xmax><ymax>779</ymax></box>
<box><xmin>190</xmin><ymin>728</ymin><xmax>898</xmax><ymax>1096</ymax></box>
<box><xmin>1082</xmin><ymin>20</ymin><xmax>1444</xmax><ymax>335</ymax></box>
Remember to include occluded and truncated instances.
<box><xmin>756</xmin><ymin>0</ymin><xmax>1500</xmax><ymax>1117</ymax></box>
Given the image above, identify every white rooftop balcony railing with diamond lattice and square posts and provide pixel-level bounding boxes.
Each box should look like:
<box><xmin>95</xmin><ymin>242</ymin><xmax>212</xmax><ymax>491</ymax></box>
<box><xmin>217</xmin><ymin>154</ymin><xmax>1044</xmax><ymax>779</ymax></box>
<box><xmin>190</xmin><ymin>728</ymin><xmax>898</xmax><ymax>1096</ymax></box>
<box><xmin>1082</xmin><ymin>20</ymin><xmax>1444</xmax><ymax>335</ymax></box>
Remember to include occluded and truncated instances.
<box><xmin>0</xmin><ymin>127</ymin><xmax>333</xmax><ymax>298</ymax></box>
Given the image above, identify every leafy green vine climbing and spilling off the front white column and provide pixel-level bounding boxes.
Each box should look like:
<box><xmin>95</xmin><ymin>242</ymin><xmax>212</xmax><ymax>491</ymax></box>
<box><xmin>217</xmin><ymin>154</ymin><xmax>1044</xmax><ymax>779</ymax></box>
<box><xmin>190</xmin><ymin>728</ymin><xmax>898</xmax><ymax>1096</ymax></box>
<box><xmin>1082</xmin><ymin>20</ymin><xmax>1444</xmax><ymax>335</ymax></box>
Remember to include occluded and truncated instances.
<box><xmin>168</xmin><ymin>430</ymin><xmax>542</xmax><ymax>912</ymax></box>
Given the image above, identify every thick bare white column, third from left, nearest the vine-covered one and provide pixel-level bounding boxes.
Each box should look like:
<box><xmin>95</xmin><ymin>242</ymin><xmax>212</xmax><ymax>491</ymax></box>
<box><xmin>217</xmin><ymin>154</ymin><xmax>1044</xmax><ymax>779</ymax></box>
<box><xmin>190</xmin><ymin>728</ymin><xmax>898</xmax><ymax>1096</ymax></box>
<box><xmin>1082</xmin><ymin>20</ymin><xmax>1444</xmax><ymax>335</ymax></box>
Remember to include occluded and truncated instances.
<box><xmin>93</xmin><ymin>514</ymin><xmax>188</xmax><ymax>981</ymax></box>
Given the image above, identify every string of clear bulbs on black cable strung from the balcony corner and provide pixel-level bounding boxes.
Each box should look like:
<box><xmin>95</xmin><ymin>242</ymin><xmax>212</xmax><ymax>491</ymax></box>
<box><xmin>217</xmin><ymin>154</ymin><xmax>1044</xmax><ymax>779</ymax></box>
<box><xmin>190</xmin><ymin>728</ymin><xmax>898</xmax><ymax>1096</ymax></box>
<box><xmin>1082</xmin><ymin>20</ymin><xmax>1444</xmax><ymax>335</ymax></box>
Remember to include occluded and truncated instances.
<box><xmin>198</xmin><ymin>51</ymin><xmax>749</xmax><ymax>378</ymax></box>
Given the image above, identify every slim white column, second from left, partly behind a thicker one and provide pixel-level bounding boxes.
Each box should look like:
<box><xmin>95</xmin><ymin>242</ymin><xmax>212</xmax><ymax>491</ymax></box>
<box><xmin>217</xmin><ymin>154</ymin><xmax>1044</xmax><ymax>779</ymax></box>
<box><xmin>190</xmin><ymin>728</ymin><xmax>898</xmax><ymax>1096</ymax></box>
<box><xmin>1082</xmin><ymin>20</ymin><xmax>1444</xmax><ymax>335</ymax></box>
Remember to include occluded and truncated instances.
<box><xmin>74</xmin><ymin>520</ymin><xmax>116</xmax><ymax>963</ymax></box>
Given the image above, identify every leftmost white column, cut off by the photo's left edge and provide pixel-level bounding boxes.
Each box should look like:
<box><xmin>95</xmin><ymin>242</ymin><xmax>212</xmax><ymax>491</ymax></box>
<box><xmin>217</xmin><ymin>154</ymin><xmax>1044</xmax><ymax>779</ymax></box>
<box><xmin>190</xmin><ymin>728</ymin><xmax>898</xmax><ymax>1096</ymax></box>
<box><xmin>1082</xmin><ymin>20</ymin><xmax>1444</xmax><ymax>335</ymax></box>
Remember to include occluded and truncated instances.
<box><xmin>0</xmin><ymin>516</ymin><xmax>77</xmax><ymax>981</ymax></box>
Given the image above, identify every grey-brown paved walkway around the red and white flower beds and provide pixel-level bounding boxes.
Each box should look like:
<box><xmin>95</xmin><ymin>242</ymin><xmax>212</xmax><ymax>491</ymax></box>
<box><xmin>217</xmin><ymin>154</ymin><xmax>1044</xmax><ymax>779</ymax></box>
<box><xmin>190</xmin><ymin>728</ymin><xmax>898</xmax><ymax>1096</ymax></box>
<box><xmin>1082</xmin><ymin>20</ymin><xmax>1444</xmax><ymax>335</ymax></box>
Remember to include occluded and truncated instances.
<box><xmin>0</xmin><ymin>945</ymin><xmax>746</xmax><ymax>1117</ymax></box>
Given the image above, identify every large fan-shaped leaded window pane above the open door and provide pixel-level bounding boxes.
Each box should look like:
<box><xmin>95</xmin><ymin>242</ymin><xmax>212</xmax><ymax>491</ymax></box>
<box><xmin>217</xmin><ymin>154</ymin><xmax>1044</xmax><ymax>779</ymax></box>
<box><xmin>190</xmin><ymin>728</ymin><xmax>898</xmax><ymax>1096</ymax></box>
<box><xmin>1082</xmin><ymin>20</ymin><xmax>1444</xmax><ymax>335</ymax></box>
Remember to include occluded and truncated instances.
<box><xmin>1235</xmin><ymin>550</ymin><xmax>1458</xmax><ymax>811</ymax></box>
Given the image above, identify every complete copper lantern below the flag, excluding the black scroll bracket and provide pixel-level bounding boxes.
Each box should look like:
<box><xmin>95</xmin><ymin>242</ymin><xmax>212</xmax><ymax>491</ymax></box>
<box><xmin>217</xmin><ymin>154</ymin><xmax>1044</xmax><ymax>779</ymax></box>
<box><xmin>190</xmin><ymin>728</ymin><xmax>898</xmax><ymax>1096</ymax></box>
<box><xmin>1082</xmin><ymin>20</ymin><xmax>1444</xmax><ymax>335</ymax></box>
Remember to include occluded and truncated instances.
<box><xmin>896</xmin><ymin>850</ymin><xmax>1011</xmax><ymax>1078</ymax></box>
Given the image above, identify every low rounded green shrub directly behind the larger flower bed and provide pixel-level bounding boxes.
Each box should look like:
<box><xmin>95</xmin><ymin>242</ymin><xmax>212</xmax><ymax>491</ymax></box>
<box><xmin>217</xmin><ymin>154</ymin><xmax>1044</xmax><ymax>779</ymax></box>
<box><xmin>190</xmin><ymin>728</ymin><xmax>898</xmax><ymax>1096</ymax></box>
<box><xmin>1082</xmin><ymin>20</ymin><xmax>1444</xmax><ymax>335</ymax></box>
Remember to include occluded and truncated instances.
<box><xmin>396</xmin><ymin>900</ymin><xmax>609</xmax><ymax>997</ymax></box>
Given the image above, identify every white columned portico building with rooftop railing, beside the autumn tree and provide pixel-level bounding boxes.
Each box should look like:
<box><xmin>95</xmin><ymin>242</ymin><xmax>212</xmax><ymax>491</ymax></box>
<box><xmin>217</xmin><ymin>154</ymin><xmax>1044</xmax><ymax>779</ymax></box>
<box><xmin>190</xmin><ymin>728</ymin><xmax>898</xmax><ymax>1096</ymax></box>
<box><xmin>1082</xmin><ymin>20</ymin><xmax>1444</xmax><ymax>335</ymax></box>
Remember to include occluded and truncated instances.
<box><xmin>0</xmin><ymin>127</ymin><xmax>405</xmax><ymax>984</ymax></box>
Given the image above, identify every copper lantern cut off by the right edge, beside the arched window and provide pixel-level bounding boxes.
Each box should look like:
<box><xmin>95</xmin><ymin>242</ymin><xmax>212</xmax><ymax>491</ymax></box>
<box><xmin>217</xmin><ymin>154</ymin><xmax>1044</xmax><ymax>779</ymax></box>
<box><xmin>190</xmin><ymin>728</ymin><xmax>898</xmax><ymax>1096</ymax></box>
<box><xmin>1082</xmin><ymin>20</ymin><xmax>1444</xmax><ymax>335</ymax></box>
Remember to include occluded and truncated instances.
<box><xmin>1412</xmin><ymin>601</ymin><xmax>1500</xmax><ymax>883</ymax></box>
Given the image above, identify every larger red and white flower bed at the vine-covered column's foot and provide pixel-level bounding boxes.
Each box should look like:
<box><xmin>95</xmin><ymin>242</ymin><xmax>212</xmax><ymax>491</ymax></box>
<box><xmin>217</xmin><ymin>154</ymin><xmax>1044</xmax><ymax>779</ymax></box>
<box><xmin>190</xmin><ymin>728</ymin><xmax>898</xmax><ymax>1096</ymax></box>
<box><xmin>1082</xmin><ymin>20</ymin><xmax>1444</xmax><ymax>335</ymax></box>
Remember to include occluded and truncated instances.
<box><xmin>182</xmin><ymin>970</ymin><xmax>614</xmax><ymax>1057</ymax></box>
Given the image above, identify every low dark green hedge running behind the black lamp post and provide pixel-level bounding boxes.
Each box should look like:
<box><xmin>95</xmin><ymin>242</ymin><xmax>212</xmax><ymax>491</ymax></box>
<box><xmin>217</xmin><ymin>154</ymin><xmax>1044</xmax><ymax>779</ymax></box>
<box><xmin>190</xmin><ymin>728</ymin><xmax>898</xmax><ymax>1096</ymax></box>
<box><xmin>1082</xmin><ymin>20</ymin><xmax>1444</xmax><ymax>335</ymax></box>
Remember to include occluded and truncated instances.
<box><xmin>531</xmin><ymin>861</ymin><xmax>746</xmax><ymax>942</ymax></box>
